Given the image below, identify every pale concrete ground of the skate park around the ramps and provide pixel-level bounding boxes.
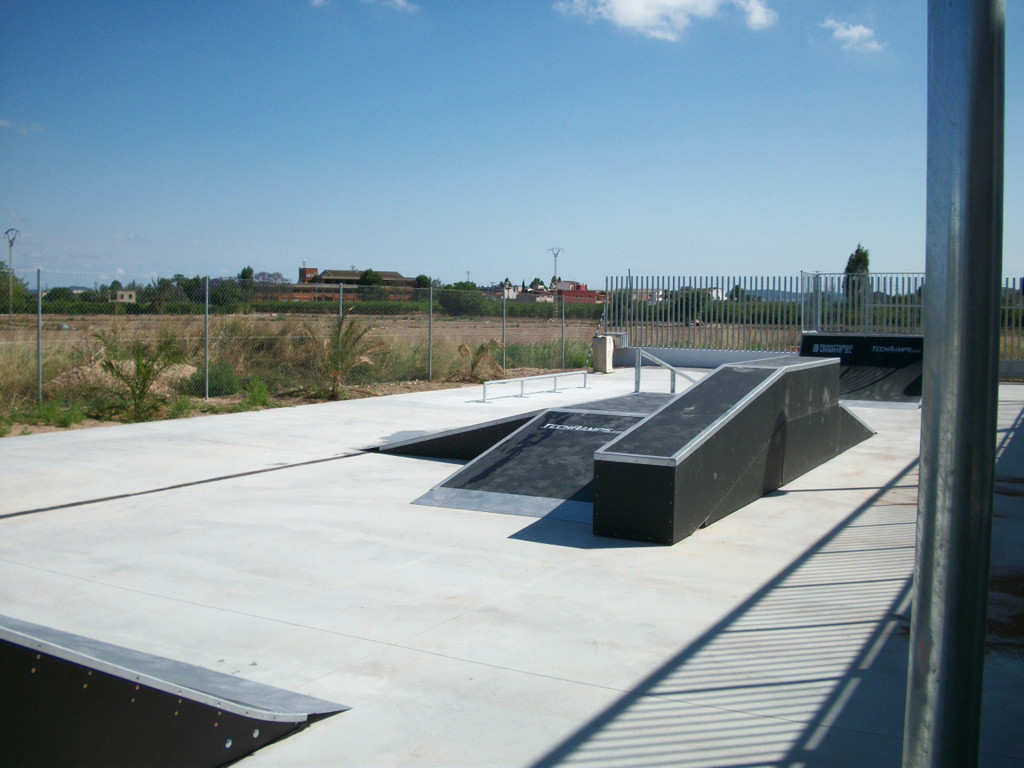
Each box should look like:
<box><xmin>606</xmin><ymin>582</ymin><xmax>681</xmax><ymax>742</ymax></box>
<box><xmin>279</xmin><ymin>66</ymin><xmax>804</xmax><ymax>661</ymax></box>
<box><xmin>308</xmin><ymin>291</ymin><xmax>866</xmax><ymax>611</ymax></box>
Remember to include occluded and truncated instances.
<box><xmin>0</xmin><ymin>371</ymin><xmax>1024</xmax><ymax>768</ymax></box>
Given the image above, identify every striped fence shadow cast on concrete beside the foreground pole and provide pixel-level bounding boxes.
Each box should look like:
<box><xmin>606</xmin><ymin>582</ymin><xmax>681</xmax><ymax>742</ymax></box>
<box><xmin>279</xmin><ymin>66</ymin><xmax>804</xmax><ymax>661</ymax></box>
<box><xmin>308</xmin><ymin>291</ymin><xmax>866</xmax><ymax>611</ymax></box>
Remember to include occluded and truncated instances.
<box><xmin>534</xmin><ymin>461</ymin><xmax>916</xmax><ymax>768</ymax></box>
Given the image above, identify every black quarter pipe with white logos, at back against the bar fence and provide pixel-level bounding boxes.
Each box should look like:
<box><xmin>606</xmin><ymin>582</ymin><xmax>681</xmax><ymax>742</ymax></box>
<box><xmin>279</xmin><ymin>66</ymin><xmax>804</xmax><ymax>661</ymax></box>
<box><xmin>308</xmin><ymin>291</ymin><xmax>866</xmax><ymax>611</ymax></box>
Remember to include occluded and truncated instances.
<box><xmin>800</xmin><ymin>333</ymin><xmax>924</xmax><ymax>407</ymax></box>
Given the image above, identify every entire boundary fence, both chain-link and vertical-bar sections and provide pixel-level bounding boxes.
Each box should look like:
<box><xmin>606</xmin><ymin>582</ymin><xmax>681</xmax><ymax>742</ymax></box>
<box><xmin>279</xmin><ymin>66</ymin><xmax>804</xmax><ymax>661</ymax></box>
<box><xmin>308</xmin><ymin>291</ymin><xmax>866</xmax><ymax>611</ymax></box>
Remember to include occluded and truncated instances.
<box><xmin>8</xmin><ymin>266</ymin><xmax>1024</xmax><ymax>416</ymax></box>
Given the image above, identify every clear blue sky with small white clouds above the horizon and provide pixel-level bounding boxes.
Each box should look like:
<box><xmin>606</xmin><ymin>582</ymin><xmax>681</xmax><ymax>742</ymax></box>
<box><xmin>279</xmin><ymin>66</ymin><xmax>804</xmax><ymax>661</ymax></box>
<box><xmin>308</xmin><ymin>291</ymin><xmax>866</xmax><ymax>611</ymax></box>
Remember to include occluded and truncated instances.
<box><xmin>0</xmin><ymin>0</ymin><xmax>1024</xmax><ymax>286</ymax></box>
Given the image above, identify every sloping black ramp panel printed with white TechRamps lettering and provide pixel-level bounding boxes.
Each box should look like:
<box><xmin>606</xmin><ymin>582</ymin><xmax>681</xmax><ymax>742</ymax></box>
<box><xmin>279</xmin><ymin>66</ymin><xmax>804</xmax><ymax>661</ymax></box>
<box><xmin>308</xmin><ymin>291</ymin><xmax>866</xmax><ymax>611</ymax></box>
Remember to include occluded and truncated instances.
<box><xmin>441</xmin><ymin>411</ymin><xmax>640</xmax><ymax>502</ymax></box>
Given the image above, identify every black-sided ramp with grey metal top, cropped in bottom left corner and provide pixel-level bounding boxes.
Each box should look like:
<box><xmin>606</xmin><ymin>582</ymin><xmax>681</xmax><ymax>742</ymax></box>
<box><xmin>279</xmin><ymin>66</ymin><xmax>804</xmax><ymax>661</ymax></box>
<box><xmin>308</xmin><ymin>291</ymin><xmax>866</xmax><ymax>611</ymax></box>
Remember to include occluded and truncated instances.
<box><xmin>0</xmin><ymin>616</ymin><xmax>348</xmax><ymax>768</ymax></box>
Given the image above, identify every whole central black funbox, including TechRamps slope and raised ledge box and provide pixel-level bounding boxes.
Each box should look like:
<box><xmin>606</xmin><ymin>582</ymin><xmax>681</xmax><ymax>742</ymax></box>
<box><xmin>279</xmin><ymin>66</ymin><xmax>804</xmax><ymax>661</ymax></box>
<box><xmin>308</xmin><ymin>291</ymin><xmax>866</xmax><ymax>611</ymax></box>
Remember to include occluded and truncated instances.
<box><xmin>399</xmin><ymin>356</ymin><xmax>872</xmax><ymax>544</ymax></box>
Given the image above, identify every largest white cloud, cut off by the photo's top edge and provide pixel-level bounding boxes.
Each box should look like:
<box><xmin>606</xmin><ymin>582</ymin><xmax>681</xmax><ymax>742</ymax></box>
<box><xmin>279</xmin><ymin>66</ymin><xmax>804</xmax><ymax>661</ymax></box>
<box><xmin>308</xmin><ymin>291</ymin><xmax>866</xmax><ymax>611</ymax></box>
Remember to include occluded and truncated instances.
<box><xmin>554</xmin><ymin>0</ymin><xmax>777</xmax><ymax>41</ymax></box>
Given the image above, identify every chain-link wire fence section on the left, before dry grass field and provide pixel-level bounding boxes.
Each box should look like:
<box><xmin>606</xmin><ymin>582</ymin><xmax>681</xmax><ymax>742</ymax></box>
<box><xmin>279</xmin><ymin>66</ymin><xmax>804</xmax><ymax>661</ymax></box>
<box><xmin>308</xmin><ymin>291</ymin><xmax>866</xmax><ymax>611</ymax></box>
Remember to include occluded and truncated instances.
<box><xmin>0</xmin><ymin>269</ymin><xmax>601</xmax><ymax>416</ymax></box>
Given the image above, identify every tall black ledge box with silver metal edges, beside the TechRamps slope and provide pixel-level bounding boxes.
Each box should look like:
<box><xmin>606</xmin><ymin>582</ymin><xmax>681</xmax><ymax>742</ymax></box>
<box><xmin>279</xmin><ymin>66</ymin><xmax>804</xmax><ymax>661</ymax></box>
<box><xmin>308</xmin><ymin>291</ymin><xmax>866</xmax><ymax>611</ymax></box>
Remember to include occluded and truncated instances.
<box><xmin>593</xmin><ymin>356</ymin><xmax>872</xmax><ymax>544</ymax></box>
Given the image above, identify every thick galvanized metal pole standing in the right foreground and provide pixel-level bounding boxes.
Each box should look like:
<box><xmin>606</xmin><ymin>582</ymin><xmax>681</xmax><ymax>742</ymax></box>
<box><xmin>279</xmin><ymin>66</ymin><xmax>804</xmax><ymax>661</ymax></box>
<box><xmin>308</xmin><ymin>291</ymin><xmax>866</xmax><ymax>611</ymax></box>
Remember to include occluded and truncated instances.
<box><xmin>903</xmin><ymin>0</ymin><xmax>1005</xmax><ymax>768</ymax></box>
